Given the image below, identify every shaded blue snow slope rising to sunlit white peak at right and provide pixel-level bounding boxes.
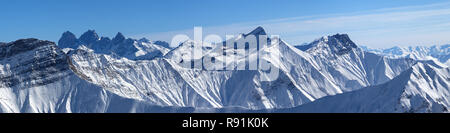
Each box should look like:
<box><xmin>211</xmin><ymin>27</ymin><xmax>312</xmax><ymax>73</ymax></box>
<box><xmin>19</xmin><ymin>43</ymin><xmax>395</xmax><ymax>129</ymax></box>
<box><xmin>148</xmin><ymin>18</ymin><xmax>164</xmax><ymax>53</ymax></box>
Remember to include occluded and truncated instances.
<box><xmin>275</xmin><ymin>63</ymin><xmax>450</xmax><ymax>113</ymax></box>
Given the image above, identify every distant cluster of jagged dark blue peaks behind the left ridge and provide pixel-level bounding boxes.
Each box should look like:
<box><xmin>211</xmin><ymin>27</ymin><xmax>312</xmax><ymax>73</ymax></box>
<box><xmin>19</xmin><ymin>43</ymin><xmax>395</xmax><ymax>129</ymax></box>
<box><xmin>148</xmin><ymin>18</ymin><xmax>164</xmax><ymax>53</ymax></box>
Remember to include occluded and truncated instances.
<box><xmin>58</xmin><ymin>30</ymin><xmax>170</xmax><ymax>60</ymax></box>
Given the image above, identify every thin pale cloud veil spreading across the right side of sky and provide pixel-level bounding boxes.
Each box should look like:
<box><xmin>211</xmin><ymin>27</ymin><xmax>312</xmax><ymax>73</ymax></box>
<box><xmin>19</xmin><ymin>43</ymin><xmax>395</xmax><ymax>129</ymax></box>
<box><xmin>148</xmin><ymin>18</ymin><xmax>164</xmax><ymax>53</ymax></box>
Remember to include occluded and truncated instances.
<box><xmin>134</xmin><ymin>3</ymin><xmax>450</xmax><ymax>47</ymax></box>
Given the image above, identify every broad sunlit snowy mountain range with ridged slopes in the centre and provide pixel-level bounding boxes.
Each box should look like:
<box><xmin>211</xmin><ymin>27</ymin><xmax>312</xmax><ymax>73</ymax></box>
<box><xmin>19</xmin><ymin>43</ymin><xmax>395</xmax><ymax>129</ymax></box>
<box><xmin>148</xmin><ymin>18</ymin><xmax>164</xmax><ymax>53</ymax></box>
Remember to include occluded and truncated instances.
<box><xmin>65</xmin><ymin>27</ymin><xmax>415</xmax><ymax>109</ymax></box>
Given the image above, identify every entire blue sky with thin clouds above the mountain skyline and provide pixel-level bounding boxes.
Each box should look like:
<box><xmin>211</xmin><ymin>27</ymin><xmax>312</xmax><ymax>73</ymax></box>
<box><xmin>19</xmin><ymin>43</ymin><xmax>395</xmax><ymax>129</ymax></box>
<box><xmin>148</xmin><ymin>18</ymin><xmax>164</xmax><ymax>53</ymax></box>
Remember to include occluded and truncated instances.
<box><xmin>0</xmin><ymin>0</ymin><xmax>450</xmax><ymax>48</ymax></box>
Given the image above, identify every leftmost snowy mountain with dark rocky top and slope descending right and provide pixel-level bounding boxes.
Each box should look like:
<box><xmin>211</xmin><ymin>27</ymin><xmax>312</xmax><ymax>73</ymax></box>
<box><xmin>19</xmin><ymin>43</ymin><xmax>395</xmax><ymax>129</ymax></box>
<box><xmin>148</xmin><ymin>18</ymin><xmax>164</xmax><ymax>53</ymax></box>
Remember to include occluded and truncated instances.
<box><xmin>0</xmin><ymin>39</ymin><xmax>176</xmax><ymax>113</ymax></box>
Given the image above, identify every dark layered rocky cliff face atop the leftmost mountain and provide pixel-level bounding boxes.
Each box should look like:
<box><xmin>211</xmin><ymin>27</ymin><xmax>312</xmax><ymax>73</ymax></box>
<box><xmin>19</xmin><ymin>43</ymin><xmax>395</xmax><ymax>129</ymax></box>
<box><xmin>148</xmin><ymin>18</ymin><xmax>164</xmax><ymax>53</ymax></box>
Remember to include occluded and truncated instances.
<box><xmin>0</xmin><ymin>39</ymin><xmax>70</xmax><ymax>87</ymax></box>
